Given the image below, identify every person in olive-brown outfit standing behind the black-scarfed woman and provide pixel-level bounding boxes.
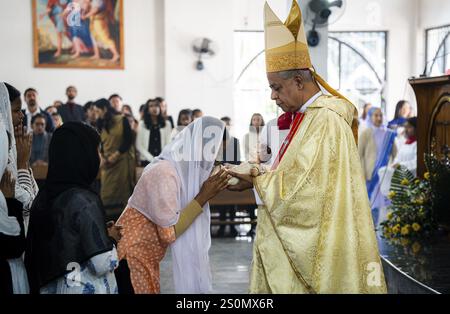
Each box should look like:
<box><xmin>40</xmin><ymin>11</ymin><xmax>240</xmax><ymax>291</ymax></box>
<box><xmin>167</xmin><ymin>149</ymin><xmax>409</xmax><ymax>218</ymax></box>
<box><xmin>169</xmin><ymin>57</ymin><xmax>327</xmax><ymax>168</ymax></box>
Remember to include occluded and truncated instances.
<box><xmin>95</xmin><ymin>99</ymin><xmax>136</xmax><ymax>220</ymax></box>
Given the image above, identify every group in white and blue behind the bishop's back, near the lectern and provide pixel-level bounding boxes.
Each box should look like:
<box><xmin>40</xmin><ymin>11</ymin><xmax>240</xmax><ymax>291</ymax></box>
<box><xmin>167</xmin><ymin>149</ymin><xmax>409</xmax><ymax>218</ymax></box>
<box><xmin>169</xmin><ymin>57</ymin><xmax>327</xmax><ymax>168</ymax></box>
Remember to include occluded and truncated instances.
<box><xmin>358</xmin><ymin>100</ymin><xmax>417</xmax><ymax>225</ymax></box>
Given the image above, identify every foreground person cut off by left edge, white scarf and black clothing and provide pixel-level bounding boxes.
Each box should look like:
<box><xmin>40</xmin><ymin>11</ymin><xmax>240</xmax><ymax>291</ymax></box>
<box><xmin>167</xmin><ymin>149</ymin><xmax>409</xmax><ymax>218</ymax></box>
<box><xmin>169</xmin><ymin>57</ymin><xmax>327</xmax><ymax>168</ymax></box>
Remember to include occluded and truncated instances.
<box><xmin>0</xmin><ymin>119</ymin><xmax>29</xmax><ymax>295</ymax></box>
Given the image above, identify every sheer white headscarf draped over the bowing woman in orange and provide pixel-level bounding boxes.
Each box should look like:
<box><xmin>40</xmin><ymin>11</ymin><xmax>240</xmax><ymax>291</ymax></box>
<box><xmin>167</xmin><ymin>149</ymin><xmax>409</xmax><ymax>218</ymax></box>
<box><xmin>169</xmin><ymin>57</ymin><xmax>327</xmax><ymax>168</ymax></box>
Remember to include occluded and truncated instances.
<box><xmin>128</xmin><ymin>117</ymin><xmax>225</xmax><ymax>293</ymax></box>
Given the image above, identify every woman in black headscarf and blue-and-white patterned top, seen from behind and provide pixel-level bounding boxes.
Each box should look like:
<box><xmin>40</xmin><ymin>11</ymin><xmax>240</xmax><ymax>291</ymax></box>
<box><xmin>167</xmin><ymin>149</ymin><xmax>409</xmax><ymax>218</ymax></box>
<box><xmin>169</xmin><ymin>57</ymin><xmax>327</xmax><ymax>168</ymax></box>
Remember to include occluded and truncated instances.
<box><xmin>25</xmin><ymin>122</ymin><xmax>120</xmax><ymax>294</ymax></box>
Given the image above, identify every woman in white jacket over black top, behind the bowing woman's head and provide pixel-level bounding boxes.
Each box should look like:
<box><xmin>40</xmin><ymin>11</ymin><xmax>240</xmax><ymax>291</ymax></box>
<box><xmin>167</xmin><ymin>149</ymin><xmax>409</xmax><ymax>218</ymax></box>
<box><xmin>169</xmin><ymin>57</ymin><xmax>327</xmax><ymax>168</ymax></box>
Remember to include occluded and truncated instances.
<box><xmin>136</xmin><ymin>99</ymin><xmax>172</xmax><ymax>166</ymax></box>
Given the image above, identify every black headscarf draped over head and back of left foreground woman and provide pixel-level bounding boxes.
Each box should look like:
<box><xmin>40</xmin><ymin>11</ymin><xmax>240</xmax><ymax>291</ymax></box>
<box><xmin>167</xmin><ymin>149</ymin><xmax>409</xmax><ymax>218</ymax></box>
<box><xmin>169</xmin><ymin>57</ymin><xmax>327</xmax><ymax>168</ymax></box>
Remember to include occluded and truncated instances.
<box><xmin>25</xmin><ymin>122</ymin><xmax>112</xmax><ymax>292</ymax></box>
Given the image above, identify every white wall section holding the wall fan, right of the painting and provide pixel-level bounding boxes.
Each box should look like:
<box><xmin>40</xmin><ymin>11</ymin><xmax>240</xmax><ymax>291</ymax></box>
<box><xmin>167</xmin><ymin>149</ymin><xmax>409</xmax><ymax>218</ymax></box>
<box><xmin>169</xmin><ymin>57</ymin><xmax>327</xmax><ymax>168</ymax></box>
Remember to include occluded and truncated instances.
<box><xmin>165</xmin><ymin>0</ymin><xmax>233</xmax><ymax>117</ymax></box>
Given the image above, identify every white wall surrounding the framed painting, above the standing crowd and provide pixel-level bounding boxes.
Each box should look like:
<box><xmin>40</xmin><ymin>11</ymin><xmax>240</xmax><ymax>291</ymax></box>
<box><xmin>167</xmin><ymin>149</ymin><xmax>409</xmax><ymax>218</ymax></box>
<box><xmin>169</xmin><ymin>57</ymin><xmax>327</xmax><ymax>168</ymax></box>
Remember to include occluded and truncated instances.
<box><xmin>0</xmin><ymin>0</ymin><xmax>165</xmax><ymax>110</ymax></box>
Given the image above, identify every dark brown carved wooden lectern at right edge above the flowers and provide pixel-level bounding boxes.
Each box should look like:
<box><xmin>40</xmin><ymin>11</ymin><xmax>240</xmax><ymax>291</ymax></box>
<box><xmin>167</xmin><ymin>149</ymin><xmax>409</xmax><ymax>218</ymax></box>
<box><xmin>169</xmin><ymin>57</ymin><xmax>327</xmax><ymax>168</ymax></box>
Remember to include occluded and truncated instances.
<box><xmin>409</xmin><ymin>75</ymin><xmax>450</xmax><ymax>176</ymax></box>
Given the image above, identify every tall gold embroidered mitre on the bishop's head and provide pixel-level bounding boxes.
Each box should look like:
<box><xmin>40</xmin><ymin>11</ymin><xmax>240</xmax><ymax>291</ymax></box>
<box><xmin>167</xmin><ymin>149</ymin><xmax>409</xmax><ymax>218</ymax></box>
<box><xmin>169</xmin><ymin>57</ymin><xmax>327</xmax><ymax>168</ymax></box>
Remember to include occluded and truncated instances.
<box><xmin>264</xmin><ymin>0</ymin><xmax>312</xmax><ymax>73</ymax></box>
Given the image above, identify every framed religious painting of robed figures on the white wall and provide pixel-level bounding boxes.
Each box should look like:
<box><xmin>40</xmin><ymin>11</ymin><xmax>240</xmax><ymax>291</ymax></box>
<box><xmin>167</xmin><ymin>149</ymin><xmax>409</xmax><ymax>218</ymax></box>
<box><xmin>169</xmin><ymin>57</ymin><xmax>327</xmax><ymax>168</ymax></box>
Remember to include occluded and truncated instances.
<box><xmin>32</xmin><ymin>0</ymin><xmax>124</xmax><ymax>69</ymax></box>
